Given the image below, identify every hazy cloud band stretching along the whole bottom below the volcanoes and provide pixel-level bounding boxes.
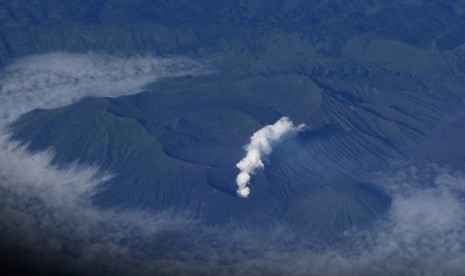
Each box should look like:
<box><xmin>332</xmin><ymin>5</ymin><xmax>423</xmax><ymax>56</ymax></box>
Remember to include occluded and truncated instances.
<box><xmin>0</xmin><ymin>150</ymin><xmax>465</xmax><ymax>275</ymax></box>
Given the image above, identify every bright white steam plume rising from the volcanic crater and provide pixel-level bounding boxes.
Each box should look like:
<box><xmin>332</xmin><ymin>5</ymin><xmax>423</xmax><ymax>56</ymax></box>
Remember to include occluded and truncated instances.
<box><xmin>236</xmin><ymin>117</ymin><xmax>306</xmax><ymax>198</ymax></box>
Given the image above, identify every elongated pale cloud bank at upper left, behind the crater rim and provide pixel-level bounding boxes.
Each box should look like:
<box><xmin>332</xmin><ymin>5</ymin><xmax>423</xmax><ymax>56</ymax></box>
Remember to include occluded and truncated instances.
<box><xmin>0</xmin><ymin>53</ymin><xmax>205</xmax><ymax>126</ymax></box>
